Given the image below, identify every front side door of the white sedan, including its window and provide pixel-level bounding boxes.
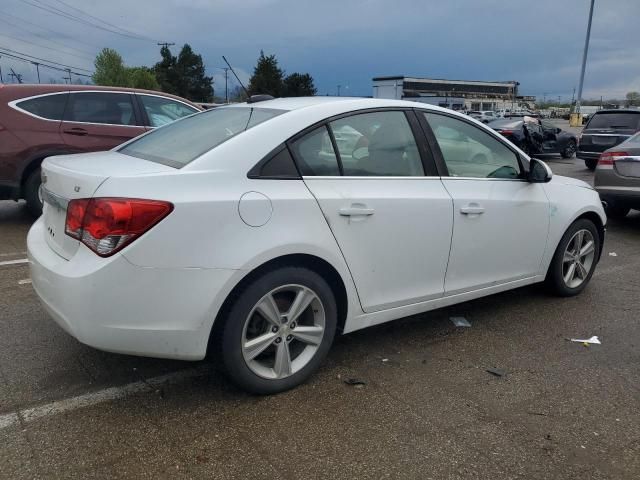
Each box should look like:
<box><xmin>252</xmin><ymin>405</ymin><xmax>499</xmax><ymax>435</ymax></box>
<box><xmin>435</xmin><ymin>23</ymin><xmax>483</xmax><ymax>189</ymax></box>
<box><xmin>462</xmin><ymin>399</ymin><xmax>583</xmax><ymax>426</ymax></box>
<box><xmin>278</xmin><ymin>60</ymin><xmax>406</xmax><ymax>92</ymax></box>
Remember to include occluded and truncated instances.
<box><xmin>423</xmin><ymin>113</ymin><xmax>549</xmax><ymax>295</ymax></box>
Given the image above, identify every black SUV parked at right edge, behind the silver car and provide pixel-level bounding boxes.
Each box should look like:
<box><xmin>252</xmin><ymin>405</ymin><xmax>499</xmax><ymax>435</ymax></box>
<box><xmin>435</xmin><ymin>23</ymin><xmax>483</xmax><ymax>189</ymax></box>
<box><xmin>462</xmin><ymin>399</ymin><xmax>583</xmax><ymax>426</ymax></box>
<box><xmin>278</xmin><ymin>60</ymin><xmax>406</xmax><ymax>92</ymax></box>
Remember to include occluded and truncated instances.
<box><xmin>577</xmin><ymin>109</ymin><xmax>640</xmax><ymax>170</ymax></box>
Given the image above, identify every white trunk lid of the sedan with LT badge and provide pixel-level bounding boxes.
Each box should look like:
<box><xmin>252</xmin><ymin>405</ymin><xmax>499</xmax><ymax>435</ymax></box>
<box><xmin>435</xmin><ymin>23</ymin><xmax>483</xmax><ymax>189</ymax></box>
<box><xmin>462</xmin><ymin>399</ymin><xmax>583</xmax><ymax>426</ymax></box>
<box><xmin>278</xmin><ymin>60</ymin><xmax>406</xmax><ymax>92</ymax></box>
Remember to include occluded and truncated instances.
<box><xmin>41</xmin><ymin>151</ymin><xmax>176</xmax><ymax>260</ymax></box>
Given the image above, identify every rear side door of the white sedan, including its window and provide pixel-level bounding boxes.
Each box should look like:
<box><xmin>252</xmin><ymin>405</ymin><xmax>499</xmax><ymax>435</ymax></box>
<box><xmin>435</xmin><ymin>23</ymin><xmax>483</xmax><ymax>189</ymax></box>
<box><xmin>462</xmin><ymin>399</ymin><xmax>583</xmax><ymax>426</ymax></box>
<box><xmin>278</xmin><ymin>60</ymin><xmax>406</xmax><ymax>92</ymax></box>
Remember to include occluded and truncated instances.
<box><xmin>290</xmin><ymin>110</ymin><xmax>453</xmax><ymax>312</ymax></box>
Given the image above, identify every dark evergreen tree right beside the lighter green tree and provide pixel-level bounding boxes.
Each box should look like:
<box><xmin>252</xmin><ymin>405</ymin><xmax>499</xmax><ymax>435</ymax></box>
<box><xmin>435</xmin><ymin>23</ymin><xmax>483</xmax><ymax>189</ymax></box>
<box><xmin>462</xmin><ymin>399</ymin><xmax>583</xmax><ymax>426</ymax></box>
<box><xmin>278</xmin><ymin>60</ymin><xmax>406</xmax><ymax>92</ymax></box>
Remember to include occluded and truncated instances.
<box><xmin>153</xmin><ymin>44</ymin><xmax>213</xmax><ymax>102</ymax></box>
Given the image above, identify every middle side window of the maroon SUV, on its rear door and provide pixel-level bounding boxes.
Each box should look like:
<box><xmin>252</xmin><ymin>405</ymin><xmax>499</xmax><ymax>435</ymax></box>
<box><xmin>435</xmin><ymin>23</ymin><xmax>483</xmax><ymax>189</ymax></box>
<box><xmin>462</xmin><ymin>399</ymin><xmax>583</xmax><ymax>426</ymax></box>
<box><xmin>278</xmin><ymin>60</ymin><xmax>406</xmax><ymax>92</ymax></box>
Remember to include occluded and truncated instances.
<box><xmin>64</xmin><ymin>92</ymin><xmax>136</xmax><ymax>125</ymax></box>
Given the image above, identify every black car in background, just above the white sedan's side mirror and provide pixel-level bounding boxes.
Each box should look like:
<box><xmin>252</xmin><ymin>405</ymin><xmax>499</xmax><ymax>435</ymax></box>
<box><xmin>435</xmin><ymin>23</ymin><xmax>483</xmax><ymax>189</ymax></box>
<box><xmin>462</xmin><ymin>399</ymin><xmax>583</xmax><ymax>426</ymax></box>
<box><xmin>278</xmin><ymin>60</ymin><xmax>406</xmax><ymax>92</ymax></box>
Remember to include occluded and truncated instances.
<box><xmin>489</xmin><ymin>116</ymin><xmax>578</xmax><ymax>158</ymax></box>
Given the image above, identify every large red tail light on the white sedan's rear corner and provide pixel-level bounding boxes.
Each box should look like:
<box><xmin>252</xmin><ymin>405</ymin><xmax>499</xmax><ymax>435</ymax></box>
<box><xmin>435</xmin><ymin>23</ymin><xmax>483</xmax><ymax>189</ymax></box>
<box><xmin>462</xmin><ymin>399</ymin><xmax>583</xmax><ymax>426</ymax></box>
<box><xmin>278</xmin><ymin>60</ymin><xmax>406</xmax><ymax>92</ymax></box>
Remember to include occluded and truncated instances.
<box><xmin>64</xmin><ymin>198</ymin><xmax>173</xmax><ymax>257</ymax></box>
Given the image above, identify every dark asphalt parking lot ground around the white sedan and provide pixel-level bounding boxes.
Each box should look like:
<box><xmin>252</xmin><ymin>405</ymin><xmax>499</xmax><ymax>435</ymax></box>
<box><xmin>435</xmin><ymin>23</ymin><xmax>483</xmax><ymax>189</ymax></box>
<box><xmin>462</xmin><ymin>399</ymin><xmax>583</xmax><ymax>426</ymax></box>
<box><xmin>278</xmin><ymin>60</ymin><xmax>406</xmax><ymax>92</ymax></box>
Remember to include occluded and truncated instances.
<box><xmin>0</xmin><ymin>125</ymin><xmax>640</xmax><ymax>479</ymax></box>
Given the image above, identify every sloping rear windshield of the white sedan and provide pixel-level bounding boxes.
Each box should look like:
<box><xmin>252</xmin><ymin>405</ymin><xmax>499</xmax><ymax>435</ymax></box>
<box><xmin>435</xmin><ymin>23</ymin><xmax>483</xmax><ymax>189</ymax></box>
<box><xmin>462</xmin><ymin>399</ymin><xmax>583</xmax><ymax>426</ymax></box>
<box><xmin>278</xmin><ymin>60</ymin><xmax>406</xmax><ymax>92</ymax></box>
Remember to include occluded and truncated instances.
<box><xmin>118</xmin><ymin>107</ymin><xmax>286</xmax><ymax>168</ymax></box>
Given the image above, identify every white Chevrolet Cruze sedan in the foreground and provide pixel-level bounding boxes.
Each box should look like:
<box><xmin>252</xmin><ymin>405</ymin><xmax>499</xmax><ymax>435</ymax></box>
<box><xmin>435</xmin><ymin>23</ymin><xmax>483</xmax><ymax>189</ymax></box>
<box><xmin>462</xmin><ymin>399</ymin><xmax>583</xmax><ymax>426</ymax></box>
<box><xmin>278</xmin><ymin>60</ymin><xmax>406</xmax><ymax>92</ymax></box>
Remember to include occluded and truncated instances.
<box><xmin>28</xmin><ymin>98</ymin><xmax>606</xmax><ymax>393</ymax></box>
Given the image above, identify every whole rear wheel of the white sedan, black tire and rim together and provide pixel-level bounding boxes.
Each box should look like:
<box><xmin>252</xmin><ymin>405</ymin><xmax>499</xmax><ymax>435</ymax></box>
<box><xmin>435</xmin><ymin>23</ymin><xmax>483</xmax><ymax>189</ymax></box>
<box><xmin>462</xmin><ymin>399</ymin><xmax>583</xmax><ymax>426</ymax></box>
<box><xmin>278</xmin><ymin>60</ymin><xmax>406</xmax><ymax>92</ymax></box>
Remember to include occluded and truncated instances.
<box><xmin>217</xmin><ymin>266</ymin><xmax>338</xmax><ymax>395</ymax></box>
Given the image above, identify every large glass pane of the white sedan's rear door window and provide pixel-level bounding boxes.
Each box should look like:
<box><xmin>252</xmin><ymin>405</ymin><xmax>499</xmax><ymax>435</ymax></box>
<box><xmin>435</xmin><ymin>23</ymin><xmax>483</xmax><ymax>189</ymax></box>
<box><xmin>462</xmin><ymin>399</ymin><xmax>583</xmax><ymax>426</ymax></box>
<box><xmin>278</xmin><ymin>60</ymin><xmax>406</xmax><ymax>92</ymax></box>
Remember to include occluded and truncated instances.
<box><xmin>330</xmin><ymin>112</ymin><xmax>424</xmax><ymax>177</ymax></box>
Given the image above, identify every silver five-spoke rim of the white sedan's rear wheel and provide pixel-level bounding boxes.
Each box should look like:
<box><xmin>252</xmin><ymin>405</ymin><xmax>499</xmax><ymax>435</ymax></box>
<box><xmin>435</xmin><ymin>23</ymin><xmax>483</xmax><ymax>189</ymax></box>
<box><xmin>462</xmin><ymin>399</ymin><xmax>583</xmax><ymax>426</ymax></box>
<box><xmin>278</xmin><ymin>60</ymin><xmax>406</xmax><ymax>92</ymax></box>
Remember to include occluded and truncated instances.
<box><xmin>242</xmin><ymin>285</ymin><xmax>325</xmax><ymax>379</ymax></box>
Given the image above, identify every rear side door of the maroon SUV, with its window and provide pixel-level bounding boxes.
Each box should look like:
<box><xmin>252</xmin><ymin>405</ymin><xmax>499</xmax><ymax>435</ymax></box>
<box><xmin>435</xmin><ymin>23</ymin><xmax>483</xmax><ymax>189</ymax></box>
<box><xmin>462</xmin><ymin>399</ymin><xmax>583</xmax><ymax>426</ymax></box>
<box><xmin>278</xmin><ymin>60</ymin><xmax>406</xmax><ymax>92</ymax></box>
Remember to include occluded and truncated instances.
<box><xmin>60</xmin><ymin>91</ymin><xmax>145</xmax><ymax>152</ymax></box>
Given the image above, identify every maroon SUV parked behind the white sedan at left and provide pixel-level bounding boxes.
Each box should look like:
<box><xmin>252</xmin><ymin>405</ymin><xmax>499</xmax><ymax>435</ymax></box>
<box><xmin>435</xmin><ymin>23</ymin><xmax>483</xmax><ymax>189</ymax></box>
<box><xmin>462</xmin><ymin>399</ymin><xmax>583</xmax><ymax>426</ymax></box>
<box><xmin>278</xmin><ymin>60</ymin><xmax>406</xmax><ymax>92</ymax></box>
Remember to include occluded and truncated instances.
<box><xmin>0</xmin><ymin>84</ymin><xmax>201</xmax><ymax>215</ymax></box>
